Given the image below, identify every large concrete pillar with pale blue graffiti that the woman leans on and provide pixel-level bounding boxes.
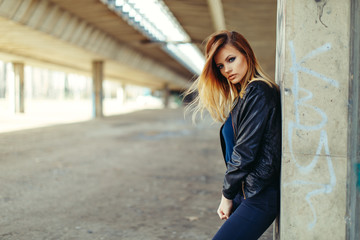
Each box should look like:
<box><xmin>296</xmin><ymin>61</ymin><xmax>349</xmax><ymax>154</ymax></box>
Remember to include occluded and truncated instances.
<box><xmin>276</xmin><ymin>0</ymin><xmax>359</xmax><ymax>240</ymax></box>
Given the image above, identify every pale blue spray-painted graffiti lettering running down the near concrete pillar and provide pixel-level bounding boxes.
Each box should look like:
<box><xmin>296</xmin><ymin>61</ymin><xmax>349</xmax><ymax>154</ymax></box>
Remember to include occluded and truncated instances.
<box><xmin>284</xmin><ymin>41</ymin><xmax>339</xmax><ymax>230</ymax></box>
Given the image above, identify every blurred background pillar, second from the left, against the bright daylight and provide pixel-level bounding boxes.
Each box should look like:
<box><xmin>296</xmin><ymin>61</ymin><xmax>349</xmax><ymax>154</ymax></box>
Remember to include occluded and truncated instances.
<box><xmin>92</xmin><ymin>61</ymin><xmax>104</xmax><ymax>117</ymax></box>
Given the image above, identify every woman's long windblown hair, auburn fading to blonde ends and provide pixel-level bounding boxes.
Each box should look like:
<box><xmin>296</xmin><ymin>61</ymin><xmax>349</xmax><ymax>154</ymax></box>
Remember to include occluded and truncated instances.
<box><xmin>185</xmin><ymin>30</ymin><xmax>278</xmax><ymax>122</ymax></box>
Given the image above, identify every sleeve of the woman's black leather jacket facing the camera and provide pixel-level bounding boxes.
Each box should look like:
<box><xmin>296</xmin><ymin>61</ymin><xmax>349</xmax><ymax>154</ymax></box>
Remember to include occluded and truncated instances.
<box><xmin>223</xmin><ymin>84</ymin><xmax>274</xmax><ymax>199</ymax></box>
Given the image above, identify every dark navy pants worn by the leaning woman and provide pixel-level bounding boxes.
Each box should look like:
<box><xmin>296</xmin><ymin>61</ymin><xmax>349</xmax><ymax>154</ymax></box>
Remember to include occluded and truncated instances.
<box><xmin>213</xmin><ymin>184</ymin><xmax>280</xmax><ymax>240</ymax></box>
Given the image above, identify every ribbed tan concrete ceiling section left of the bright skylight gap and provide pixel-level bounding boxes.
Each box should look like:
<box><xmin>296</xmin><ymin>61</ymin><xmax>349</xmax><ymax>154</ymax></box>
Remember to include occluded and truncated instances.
<box><xmin>0</xmin><ymin>0</ymin><xmax>189</xmax><ymax>89</ymax></box>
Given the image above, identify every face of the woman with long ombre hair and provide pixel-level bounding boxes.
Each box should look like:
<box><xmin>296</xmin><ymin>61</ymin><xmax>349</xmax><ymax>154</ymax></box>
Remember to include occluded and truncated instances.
<box><xmin>214</xmin><ymin>44</ymin><xmax>248</xmax><ymax>84</ymax></box>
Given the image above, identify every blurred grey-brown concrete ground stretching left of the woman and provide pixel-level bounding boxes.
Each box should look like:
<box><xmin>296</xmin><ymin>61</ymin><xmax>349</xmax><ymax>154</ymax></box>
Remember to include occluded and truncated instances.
<box><xmin>0</xmin><ymin>109</ymin><xmax>272</xmax><ymax>240</ymax></box>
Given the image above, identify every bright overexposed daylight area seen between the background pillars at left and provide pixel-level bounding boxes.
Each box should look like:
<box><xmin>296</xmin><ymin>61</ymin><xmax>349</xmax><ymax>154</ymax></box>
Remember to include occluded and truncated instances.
<box><xmin>0</xmin><ymin>61</ymin><xmax>174</xmax><ymax>132</ymax></box>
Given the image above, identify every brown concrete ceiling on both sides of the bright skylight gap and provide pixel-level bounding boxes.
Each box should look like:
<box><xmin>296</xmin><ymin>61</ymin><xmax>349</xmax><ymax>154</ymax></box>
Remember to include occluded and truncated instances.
<box><xmin>0</xmin><ymin>0</ymin><xmax>276</xmax><ymax>88</ymax></box>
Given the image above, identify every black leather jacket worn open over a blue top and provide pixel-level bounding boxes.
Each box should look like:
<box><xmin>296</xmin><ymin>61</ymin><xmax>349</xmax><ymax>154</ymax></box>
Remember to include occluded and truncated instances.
<box><xmin>220</xmin><ymin>81</ymin><xmax>281</xmax><ymax>199</ymax></box>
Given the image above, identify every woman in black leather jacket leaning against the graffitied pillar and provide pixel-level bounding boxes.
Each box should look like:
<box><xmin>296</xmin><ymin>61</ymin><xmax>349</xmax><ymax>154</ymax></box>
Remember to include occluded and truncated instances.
<box><xmin>187</xmin><ymin>31</ymin><xmax>281</xmax><ymax>240</ymax></box>
